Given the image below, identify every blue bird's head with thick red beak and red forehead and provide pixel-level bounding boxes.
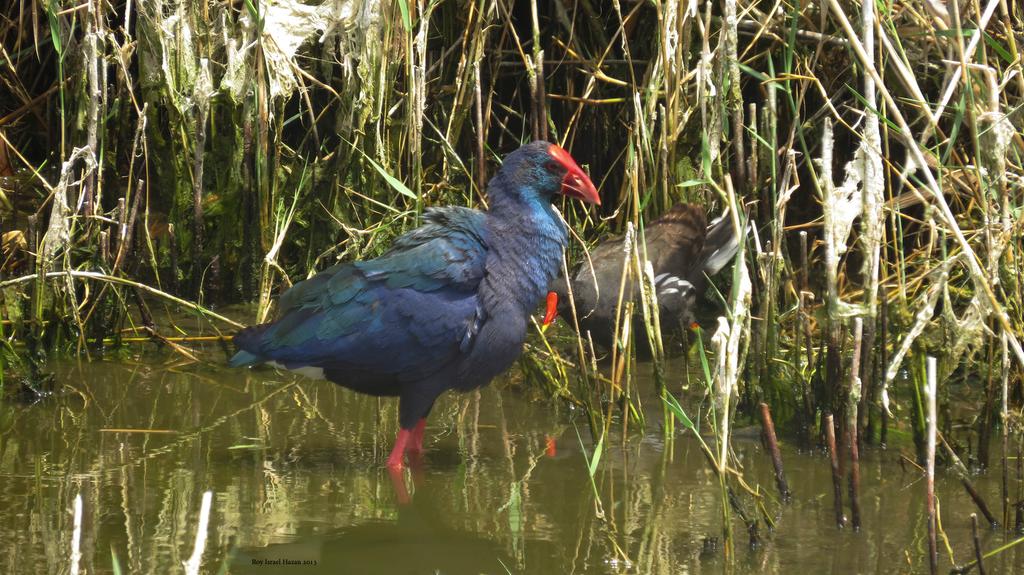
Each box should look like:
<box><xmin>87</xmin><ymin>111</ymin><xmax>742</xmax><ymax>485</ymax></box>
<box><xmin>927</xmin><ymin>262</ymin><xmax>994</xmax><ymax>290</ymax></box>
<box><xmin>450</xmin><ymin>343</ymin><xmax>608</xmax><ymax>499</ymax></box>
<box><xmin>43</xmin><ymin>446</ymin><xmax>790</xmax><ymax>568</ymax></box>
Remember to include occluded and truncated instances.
<box><xmin>489</xmin><ymin>140</ymin><xmax>601</xmax><ymax>206</ymax></box>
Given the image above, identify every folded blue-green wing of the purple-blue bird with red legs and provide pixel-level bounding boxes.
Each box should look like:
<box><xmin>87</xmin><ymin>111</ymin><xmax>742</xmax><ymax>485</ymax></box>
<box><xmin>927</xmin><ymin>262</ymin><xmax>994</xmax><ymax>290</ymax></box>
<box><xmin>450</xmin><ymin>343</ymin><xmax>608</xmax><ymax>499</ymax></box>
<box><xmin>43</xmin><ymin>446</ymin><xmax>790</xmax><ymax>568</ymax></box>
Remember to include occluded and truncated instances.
<box><xmin>236</xmin><ymin>208</ymin><xmax>487</xmax><ymax>380</ymax></box>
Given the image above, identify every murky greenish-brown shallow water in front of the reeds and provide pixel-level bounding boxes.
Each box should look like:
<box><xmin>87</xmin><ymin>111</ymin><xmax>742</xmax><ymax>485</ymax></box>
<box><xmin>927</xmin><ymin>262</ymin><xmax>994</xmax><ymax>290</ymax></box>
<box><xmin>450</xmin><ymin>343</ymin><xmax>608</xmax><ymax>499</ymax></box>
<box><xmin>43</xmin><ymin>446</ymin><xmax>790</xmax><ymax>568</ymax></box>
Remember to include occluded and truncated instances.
<box><xmin>0</xmin><ymin>352</ymin><xmax>1024</xmax><ymax>575</ymax></box>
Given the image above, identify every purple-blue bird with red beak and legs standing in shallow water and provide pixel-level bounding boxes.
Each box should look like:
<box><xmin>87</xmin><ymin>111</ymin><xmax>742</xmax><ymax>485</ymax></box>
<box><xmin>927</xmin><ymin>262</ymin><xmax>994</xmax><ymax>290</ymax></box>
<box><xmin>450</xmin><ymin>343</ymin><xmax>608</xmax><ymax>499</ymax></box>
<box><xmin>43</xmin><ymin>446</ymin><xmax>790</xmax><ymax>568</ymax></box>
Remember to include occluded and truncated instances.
<box><xmin>230</xmin><ymin>141</ymin><xmax>600</xmax><ymax>470</ymax></box>
